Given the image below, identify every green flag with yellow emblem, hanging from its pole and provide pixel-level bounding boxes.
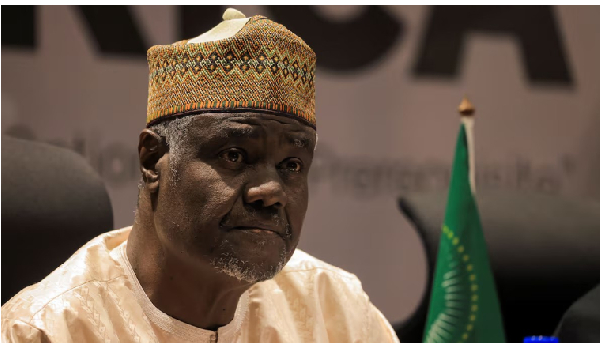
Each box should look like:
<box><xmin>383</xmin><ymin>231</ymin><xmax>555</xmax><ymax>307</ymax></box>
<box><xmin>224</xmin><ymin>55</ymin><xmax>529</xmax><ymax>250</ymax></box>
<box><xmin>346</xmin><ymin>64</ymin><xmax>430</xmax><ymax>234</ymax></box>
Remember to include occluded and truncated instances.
<box><xmin>424</xmin><ymin>112</ymin><xmax>505</xmax><ymax>342</ymax></box>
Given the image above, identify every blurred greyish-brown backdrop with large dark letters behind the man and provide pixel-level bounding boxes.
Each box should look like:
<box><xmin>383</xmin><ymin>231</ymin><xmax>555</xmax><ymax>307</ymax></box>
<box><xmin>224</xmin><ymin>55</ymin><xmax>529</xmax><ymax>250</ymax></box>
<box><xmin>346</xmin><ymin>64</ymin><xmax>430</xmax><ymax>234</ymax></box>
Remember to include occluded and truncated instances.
<box><xmin>2</xmin><ymin>6</ymin><xmax>600</xmax><ymax>322</ymax></box>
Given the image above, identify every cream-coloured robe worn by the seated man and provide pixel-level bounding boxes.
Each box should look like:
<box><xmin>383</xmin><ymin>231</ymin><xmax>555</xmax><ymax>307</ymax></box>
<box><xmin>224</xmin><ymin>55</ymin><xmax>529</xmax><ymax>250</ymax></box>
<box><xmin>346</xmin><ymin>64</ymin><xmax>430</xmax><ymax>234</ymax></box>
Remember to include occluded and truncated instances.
<box><xmin>1</xmin><ymin>227</ymin><xmax>398</xmax><ymax>342</ymax></box>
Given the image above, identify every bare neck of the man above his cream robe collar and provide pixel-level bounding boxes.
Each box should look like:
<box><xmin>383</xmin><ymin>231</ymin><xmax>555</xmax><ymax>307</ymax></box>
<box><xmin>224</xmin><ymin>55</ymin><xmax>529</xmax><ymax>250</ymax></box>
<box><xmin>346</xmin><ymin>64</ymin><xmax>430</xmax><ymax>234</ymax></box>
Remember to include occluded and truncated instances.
<box><xmin>127</xmin><ymin>207</ymin><xmax>252</xmax><ymax>330</ymax></box>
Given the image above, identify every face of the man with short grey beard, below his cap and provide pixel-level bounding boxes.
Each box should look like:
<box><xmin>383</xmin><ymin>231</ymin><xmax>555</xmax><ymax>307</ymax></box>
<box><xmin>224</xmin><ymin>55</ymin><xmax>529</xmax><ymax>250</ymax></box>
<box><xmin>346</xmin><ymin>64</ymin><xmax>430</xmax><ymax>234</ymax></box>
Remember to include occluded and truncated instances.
<box><xmin>154</xmin><ymin>113</ymin><xmax>316</xmax><ymax>282</ymax></box>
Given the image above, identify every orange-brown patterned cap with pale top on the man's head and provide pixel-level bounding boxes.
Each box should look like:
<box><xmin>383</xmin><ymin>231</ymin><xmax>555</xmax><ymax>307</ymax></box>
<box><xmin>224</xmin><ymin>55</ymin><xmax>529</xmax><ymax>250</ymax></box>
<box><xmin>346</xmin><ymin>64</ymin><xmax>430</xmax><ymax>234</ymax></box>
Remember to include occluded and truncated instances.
<box><xmin>147</xmin><ymin>9</ymin><xmax>316</xmax><ymax>128</ymax></box>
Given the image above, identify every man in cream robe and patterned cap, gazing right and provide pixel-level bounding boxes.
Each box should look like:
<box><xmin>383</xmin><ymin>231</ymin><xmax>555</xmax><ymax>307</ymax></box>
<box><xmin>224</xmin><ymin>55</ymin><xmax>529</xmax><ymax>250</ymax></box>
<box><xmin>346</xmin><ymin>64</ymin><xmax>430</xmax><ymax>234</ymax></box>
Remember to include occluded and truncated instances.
<box><xmin>2</xmin><ymin>9</ymin><xmax>397</xmax><ymax>342</ymax></box>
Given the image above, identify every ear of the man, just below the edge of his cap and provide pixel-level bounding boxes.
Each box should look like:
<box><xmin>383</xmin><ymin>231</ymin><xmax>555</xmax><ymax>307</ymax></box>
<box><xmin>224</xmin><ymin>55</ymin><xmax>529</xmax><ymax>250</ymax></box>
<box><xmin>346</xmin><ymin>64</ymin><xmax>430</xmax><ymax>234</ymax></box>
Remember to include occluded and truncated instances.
<box><xmin>138</xmin><ymin>129</ymin><xmax>168</xmax><ymax>193</ymax></box>
